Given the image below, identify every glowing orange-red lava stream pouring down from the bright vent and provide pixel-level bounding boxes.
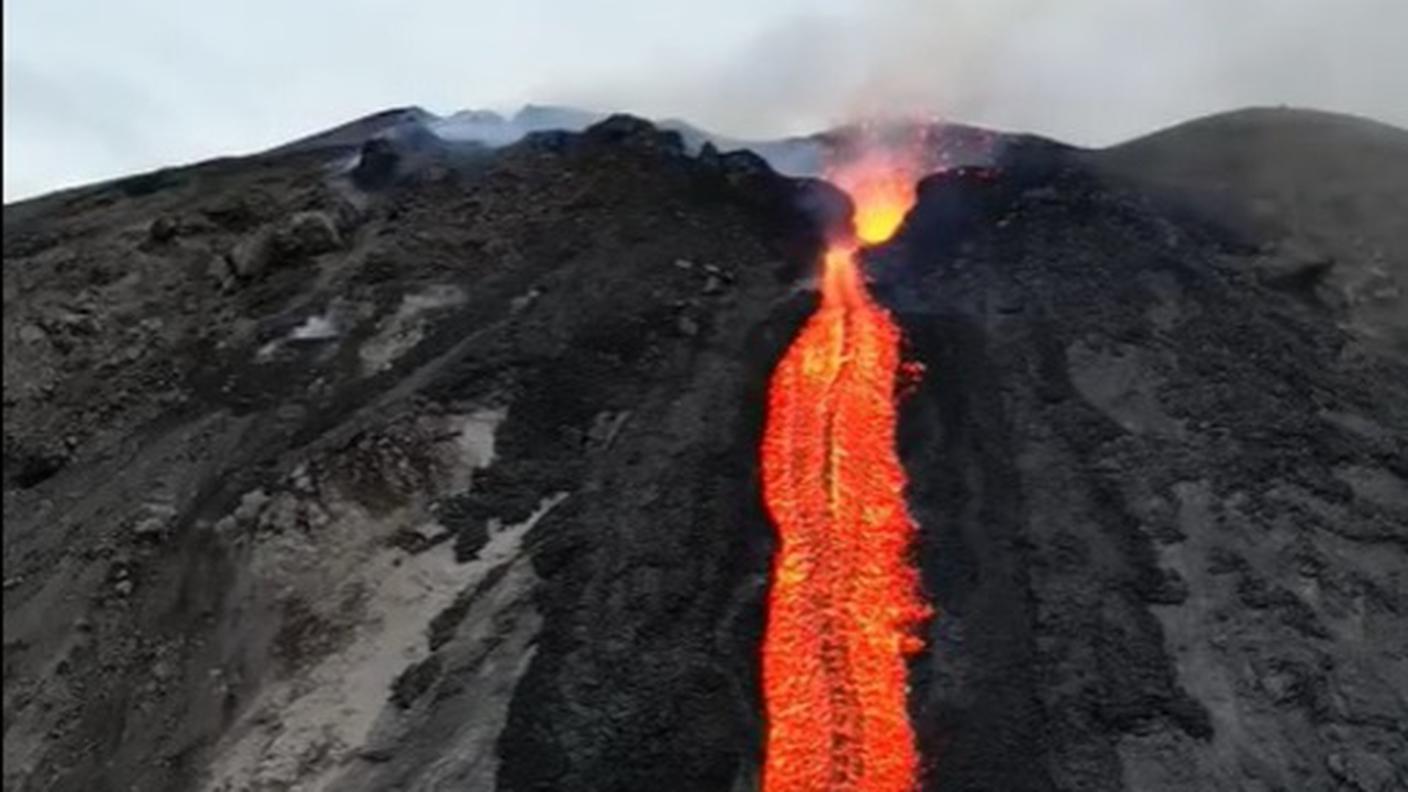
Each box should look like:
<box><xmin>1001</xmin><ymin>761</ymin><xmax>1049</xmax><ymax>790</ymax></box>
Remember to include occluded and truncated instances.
<box><xmin>762</xmin><ymin>149</ymin><xmax>928</xmax><ymax>792</ymax></box>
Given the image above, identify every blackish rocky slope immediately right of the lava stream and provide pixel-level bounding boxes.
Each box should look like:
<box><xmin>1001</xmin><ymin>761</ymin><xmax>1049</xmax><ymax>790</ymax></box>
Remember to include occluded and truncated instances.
<box><xmin>873</xmin><ymin>132</ymin><xmax>1408</xmax><ymax>789</ymax></box>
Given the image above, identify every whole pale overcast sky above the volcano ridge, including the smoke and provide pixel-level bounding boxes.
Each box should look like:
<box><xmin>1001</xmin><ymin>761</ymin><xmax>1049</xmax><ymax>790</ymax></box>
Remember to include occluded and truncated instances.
<box><xmin>4</xmin><ymin>0</ymin><xmax>1408</xmax><ymax>200</ymax></box>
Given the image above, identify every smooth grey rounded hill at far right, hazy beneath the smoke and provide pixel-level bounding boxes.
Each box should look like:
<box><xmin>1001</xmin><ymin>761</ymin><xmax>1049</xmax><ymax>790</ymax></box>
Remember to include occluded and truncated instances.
<box><xmin>1091</xmin><ymin>109</ymin><xmax>1408</xmax><ymax>349</ymax></box>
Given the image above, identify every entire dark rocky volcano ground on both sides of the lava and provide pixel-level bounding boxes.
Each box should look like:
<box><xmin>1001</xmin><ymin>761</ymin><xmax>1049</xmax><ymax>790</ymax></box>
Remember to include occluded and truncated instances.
<box><xmin>4</xmin><ymin>110</ymin><xmax>1408</xmax><ymax>792</ymax></box>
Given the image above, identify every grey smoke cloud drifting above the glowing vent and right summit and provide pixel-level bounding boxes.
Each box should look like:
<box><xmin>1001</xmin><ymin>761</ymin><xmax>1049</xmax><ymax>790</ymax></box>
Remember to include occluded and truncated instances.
<box><xmin>556</xmin><ymin>0</ymin><xmax>1408</xmax><ymax>145</ymax></box>
